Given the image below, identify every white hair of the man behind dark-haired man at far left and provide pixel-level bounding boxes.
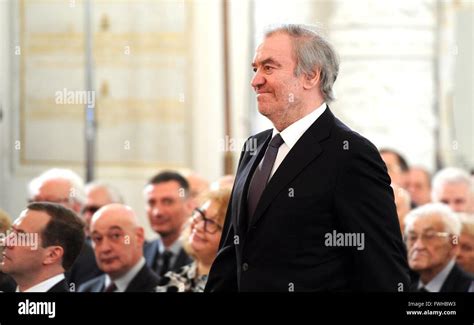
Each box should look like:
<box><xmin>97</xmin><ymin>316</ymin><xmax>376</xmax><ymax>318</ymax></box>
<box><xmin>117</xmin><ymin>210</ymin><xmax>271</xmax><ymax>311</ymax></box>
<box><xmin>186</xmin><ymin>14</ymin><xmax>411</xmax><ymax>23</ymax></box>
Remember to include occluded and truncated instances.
<box><xmin>28</xmin><ymin>168</ymin><xmax>86</xmax><ymax>205</ymax></box>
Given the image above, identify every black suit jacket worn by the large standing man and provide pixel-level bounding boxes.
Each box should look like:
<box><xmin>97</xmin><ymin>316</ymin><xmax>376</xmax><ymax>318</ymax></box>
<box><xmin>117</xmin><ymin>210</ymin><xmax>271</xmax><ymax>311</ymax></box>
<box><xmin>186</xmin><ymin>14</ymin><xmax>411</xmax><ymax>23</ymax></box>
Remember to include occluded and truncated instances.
<box><xmin>206</xmin><ymin>108</ymin><xmax>409</xmax><ymax>291</ymax></box>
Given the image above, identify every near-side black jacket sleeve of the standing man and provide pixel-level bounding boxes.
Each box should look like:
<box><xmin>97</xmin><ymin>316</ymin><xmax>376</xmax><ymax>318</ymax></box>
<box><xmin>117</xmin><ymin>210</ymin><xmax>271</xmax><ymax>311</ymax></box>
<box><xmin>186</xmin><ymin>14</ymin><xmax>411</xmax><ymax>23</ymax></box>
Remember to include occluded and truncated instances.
<box><xmin>335</xmin><ymin>137</ymin><xmax>409</xmax><ymax>291</ymax></box>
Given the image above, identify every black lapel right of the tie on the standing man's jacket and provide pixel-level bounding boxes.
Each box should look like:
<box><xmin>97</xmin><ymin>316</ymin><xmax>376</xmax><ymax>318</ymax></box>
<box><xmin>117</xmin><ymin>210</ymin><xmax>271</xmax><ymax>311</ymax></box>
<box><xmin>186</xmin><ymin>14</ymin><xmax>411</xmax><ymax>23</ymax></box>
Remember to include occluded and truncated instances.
<box><xmin>248</xmin><ymin>107</ymin><xmax>334</xmax><ymax>226</ymax></box>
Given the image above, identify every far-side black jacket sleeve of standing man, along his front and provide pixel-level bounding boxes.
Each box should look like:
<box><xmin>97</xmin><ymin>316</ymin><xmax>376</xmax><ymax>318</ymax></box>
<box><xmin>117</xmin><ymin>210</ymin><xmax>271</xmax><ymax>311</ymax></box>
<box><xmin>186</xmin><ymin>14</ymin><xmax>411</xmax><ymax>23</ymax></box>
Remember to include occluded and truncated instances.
<box><xmin>204</xmin><ymin>138</ymin><xmax>250</xmax><ymax>292</ymax></box>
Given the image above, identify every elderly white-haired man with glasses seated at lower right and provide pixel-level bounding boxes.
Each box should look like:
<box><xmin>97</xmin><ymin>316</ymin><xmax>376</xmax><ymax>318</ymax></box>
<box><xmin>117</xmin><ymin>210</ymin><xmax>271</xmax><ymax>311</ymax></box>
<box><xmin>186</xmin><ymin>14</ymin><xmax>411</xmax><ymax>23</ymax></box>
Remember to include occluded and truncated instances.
<box><xmin>405</xmin><ymin>203</ymin><xmax>473</xmax><ymax>292</ymax></box>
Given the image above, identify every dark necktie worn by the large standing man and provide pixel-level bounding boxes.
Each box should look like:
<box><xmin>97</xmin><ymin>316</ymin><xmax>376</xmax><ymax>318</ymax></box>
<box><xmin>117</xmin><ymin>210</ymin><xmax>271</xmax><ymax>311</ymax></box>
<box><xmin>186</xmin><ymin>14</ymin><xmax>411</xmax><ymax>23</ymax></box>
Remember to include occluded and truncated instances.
<box><xmin>248</xmin><ymin>133</ymin><xmax>284</xmax><ymax>221</ymax></box>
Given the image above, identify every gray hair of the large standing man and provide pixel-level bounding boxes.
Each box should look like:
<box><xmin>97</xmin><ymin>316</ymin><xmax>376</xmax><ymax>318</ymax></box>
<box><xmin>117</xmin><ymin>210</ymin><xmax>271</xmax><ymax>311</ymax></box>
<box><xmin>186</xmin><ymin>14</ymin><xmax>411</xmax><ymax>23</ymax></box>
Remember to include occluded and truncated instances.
<box><xmin>264</xmin><ymin>24</ymin><xmax>339</xmax><ymax>103</ymax></box>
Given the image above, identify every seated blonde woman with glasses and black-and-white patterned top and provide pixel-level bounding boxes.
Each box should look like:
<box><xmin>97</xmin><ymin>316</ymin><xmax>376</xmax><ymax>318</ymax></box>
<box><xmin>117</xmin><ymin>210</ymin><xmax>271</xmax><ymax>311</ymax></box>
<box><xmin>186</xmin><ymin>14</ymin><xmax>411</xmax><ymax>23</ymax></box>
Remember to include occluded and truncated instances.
<box><xmin>156</xmin><ymin>189</ymin><xmax>230</xmax><ymax>292</ymax></box>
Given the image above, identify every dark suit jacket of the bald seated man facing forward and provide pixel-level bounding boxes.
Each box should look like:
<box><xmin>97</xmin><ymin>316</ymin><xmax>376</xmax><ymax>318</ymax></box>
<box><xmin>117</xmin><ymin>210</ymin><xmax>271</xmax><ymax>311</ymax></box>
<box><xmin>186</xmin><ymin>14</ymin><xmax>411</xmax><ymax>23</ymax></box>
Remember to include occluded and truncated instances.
<box><xmin>79</xmin><ymin>264</ymin><xmax>159</xmax><ymax>292</ymax></box>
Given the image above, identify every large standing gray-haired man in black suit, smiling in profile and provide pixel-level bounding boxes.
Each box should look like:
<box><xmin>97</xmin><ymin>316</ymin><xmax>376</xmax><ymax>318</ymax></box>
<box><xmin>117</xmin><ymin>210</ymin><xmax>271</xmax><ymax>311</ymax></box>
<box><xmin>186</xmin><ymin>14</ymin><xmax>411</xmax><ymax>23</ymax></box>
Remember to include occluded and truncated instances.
<box><xmin>206</xmin><ymin>25</ymin><xmax>409</xmax><ymax>292</ymax></box>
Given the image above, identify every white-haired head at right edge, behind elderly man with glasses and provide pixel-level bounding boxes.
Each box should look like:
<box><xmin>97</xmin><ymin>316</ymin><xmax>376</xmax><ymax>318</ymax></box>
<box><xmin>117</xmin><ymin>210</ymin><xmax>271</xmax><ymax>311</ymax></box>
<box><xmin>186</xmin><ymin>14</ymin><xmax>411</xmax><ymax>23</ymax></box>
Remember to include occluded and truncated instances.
<box><xmin>431</xmin><ymin>167</ymin><xmax>474</xmax><ymax>213</ymax></box>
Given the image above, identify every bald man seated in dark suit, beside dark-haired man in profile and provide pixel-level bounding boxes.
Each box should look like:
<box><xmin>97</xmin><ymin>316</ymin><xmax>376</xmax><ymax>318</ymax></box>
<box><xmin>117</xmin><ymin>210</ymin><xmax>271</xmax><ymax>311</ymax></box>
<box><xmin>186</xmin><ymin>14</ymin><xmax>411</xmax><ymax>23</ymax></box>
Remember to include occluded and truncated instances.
<box><xmin>79</xmin><ymin>203</ymin><xmax>159</xmax><ymax>292</ymax></box>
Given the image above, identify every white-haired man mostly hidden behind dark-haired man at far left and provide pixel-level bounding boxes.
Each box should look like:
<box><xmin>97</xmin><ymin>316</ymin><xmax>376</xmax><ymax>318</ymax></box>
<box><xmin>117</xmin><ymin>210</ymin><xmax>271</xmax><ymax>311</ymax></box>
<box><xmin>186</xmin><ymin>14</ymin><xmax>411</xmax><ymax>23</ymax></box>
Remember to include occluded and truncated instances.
<box><xmin>28</xmin><ymin>168</ymin><xmax>102</xmax><ymax>290</ymax></box>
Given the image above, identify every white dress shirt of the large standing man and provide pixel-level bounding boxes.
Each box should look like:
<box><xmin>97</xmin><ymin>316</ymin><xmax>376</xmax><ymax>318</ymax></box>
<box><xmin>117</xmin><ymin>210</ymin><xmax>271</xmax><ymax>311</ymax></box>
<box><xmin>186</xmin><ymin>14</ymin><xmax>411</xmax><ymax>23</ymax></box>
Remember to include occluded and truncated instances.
<box><xmin>268</xmin><ymin>103</ymin><xmax>327</xmax><ymax>181</ymax></box>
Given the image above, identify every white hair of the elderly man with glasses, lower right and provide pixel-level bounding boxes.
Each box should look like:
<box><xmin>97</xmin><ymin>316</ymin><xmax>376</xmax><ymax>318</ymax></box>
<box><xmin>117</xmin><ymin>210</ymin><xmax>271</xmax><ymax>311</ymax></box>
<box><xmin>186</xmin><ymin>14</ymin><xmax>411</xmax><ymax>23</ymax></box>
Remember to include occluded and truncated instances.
<box><xmin>405</xmin><ymin>203</ymin><xmax>461</xmax><ymax>236</ymax></box>
